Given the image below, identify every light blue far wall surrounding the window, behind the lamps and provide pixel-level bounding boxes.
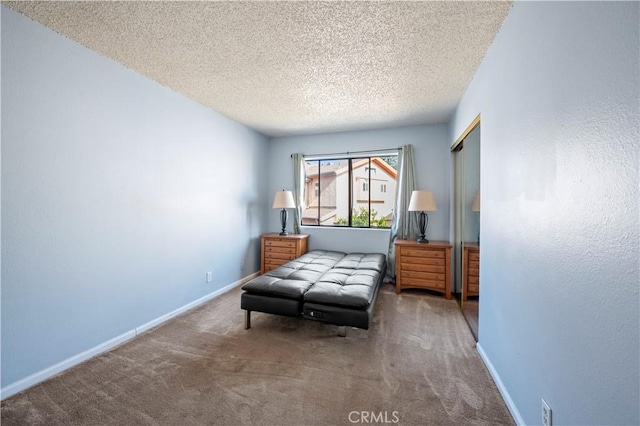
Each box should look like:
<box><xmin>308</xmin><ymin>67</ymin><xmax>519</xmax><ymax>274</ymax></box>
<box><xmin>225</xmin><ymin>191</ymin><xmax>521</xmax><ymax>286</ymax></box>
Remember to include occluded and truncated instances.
<box><xmin>268</xmin><ymin>125</ymin><xmax>450</xmax><ymax>253</ymax></box>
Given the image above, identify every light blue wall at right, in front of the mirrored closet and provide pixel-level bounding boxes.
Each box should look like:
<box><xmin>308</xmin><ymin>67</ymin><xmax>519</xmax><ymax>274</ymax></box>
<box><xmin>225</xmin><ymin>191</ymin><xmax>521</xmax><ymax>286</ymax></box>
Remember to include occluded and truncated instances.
<box><xmin>451</xmin><ymin>2</ymin><xmax>640</xmax><ymax>425</ymax></box>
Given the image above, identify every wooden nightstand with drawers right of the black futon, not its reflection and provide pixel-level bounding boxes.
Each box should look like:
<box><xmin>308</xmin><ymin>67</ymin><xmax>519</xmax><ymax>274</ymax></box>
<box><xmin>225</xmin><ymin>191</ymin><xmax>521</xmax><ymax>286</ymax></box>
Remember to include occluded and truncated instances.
<box><xmin>395</xmin><ymin>240</ymin><xmax>451</xmax><ymax>299</ymax></box>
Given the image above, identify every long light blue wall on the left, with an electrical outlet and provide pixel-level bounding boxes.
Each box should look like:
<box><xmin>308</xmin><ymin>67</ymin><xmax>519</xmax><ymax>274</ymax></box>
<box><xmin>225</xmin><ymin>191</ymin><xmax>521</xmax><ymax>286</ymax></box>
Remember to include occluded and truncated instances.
<box><xmin>2</xmin><ymin>7</ymin><xmax>268</xmax><ymax>387</ymax></box>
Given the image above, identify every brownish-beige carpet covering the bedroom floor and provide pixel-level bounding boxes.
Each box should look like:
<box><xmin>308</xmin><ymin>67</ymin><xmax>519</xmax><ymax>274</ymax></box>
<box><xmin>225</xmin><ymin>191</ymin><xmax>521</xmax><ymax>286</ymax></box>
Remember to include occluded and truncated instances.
<box><xmin>1</xmin><ymin>284</ymin><xmax>513</xmax><ymax>426</ymax></box>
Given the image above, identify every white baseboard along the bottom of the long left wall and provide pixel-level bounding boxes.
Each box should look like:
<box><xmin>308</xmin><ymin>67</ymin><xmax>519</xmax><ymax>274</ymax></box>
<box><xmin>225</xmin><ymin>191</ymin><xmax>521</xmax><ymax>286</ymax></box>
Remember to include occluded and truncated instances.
<box><xmin>0</xmin><ymin>272</ymin><xmax>260</xmax><ymax>400</ymax></box>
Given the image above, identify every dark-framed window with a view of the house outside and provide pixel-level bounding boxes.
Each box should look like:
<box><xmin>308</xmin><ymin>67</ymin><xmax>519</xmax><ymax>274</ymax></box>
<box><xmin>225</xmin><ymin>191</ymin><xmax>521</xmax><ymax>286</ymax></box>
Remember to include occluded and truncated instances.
<box><xmin>302</xmin><ymin>154</ymin><xmax>398</xmax><ymax>228</ymax></box>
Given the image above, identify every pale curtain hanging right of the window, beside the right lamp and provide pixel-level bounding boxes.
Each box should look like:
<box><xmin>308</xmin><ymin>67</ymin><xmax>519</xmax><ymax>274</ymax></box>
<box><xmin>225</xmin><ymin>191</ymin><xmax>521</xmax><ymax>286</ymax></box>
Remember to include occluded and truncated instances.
<box><xmin>387</xmin><ymin>145</ymin><xmax>418</xmax><ymax>278</ymax></box>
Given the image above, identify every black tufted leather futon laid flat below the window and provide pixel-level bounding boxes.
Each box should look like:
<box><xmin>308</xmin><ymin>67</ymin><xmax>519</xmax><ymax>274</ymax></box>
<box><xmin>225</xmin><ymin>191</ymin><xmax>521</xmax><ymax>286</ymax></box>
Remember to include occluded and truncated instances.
<box><xmin>240</xmin><ymin>250</ymin><xmax>386</xmax><ymax>329</ymax></box>
